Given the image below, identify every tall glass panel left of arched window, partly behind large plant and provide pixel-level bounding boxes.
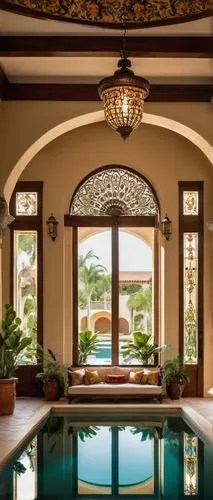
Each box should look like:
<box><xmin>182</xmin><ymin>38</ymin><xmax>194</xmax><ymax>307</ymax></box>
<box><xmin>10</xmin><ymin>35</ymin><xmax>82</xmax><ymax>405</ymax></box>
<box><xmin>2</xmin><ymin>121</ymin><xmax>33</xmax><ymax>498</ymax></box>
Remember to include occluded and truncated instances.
<box><xmin>14</xmin><ymin>231</ymin><xmax>37</xmax><ymax>364</ymax></box>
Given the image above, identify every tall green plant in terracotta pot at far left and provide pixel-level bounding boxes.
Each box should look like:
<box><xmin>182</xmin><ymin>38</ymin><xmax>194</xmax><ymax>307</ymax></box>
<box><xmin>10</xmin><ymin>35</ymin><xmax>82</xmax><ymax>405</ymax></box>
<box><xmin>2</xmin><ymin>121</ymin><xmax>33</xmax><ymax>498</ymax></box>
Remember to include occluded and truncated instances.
<box><xmin>0</xmin><ymin>304</ymin><xmax>32</xmax><ymax>415</ymax></box>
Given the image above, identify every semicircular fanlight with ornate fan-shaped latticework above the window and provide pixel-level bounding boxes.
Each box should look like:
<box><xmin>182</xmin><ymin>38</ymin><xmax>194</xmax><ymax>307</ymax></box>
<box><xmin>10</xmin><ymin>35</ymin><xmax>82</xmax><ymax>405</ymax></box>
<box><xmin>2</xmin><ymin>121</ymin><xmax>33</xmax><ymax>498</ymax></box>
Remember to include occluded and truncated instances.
<box><xmin>70</xmin><ymin>167</ymin><xmax>159</xmax><ymax>216</ymax></box>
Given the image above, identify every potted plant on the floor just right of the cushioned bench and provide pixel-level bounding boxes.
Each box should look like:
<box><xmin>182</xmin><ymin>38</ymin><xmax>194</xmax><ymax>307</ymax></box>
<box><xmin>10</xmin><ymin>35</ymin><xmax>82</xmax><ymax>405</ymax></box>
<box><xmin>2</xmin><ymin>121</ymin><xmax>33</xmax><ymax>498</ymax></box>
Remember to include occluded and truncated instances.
<box><xmin>163</xmin><ymin>356</ymin><xmax>189</xmax><ymax>399</ymax></box>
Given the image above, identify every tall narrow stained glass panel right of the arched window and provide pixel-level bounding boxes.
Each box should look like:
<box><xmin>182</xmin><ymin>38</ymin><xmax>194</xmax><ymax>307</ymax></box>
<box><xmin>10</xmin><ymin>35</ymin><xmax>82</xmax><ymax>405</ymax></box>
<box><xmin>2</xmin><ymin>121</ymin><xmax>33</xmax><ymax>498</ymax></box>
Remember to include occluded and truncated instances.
<box><xmin>184</xmin><ymin>233</ymin><xmax>198</xmax><ymax>364</ymax></box>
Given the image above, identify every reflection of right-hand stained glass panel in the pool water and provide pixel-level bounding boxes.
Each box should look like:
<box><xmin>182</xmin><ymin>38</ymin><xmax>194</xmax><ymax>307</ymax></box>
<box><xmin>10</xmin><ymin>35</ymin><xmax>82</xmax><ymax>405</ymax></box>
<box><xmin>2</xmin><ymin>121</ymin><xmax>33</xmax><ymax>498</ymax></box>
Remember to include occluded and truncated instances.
<box><xmin>184</xmin><ymin>432</ymin><xmax>198</xmax><ymax>496</ymax></box>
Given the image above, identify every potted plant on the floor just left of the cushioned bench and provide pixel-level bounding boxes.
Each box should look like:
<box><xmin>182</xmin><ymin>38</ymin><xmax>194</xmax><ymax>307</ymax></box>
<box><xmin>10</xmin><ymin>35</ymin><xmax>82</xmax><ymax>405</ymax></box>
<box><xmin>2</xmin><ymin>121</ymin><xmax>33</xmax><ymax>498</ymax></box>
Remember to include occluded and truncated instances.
<box><xmin>36</xmin><ymin>345</ymin><xmax>68</xmax><ymax>401</ymax></box>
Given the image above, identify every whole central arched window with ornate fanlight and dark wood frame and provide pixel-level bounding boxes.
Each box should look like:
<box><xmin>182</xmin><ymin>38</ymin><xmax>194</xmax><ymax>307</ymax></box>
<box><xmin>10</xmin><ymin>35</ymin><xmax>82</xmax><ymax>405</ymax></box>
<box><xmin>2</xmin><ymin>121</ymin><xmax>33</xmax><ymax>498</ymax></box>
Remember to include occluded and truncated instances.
<box><xmin>65</xmin><ymin>165</ymin><xmax>160</xmax><ymax>365</ymax></box>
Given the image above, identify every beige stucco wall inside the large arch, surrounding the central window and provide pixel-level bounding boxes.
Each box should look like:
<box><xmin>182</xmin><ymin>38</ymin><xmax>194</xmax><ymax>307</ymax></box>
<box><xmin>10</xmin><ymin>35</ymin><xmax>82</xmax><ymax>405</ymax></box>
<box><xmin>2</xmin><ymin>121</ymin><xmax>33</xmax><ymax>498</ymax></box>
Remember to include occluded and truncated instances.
<box><xmin>2</xmin><ymin>117</ymin><xmax>213</xmax><ymax>391</ymax></box>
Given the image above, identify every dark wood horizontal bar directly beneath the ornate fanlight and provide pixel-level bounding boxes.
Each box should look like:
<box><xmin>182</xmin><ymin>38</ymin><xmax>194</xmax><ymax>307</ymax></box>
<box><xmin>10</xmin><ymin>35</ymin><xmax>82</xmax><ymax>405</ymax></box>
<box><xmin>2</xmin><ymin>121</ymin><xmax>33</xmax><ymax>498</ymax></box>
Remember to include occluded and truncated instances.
<box><xmin>64</xmin><ymin>214</ymin><xmax>157</xmax><ymax>227</ymax></box>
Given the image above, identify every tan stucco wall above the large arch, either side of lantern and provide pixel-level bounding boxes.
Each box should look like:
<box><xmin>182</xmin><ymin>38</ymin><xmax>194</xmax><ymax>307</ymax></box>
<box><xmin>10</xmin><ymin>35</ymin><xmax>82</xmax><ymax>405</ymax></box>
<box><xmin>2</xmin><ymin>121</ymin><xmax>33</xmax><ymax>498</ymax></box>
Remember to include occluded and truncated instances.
<box><xmin>0</xmin><ymin>101</ymin><xmax>213</xmax><ymax>200</ymax></box>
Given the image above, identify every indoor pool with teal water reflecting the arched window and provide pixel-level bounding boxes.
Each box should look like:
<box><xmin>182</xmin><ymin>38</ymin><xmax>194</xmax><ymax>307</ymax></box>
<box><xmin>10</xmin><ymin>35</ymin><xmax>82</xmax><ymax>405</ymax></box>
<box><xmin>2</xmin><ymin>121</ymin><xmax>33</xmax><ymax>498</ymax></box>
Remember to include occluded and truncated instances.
<box><xmin>0</xmin><ymin>414</ymin><xmax>213</xmax><ymax>500</ymax></box>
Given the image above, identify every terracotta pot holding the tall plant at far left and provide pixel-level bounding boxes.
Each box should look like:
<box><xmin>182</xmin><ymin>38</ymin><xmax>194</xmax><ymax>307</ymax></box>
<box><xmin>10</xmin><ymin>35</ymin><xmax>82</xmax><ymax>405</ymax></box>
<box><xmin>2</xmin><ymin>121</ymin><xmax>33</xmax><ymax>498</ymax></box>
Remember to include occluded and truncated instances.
<box><xmin>0</xmin><ymin>377</ymin><xmax>18</xmax><ymax>415</ymax></box>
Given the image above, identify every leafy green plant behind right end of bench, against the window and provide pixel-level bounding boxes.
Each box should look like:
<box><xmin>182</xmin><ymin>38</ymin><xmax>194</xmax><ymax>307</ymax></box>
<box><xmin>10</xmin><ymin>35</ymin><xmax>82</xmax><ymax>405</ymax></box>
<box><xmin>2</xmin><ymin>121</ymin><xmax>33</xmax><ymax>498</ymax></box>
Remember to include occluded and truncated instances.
<box><xmin>121</xmin><ymin>332</ymin><xmax>171</xmax><ymax>365</ymax></box>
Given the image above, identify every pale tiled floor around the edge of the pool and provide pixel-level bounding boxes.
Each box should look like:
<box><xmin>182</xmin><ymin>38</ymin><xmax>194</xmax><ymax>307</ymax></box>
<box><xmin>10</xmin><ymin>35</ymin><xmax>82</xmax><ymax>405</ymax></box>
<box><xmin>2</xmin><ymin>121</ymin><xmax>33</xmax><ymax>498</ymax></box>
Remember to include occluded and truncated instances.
<box><xmin>0</xmin><ymin>398</ymin><xmax>213</xmax><ymax>468</ymax></box>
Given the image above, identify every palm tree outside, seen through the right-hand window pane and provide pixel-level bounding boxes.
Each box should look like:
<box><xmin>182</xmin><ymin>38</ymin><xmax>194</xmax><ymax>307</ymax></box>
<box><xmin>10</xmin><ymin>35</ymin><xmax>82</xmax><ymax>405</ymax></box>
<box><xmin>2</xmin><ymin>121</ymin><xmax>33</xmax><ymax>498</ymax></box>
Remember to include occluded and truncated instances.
<box><xmin>127</xmin><ymin>288</ymin><xmax>152</xmax><ymax>332</ymax></box>
